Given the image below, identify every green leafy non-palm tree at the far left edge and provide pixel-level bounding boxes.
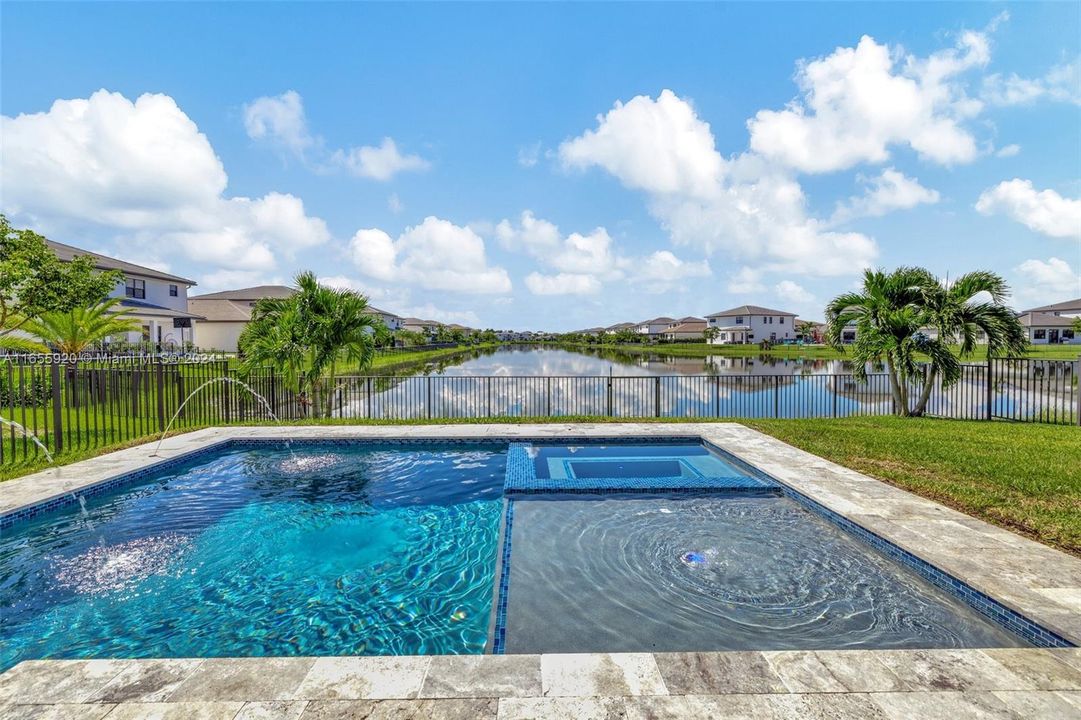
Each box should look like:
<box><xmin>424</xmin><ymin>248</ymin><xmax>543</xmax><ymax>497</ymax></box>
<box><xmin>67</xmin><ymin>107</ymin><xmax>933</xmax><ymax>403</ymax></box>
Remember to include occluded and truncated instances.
<box><xmin>0</xmin><ymin>214</ymin><xmax>123</xmax><ymax>349</ymax></box>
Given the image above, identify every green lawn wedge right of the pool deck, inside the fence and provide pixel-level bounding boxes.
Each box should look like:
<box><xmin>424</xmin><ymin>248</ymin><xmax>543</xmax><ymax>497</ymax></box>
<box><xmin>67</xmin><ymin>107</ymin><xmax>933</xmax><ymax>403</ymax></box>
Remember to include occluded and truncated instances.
<box><xmin>740</xmin><ymin>417</ymin><xmax>1081</xmax><ymax>556</ymax></box>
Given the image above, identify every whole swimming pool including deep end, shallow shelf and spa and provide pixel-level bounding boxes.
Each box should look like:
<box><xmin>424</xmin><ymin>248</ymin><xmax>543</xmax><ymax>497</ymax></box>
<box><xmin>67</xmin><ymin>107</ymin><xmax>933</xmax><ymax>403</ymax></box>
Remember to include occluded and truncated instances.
<box><xmin>0</xmin><ymin>439</ymin><xmax>1063</xmax><ymax>669</ymax></box>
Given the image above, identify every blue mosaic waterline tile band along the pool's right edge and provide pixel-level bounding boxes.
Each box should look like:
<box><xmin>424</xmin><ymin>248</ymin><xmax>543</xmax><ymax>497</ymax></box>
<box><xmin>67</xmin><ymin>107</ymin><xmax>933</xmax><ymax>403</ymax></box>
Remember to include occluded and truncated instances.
<box><xmin>703</xmin><ymin>440</ymin><xmax>1076</xmax><ymax>648</ymax></box>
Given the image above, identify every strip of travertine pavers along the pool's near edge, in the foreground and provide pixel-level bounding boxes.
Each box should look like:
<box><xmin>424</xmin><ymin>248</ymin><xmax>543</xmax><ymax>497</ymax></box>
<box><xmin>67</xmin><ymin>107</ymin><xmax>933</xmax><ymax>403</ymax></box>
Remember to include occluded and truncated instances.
<box><xmin>0</xmin><ymin>649</ymin><xmax>1081</xmax><ymax>720</ymax></box>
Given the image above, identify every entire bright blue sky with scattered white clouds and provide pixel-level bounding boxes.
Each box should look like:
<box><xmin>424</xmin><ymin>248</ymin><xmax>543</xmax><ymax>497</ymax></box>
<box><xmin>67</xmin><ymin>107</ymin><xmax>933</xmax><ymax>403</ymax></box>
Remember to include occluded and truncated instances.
<box><xmin>0</xmin><ymin>3</ymin><xmax>1081</xmax><ymax>330</ymax></box>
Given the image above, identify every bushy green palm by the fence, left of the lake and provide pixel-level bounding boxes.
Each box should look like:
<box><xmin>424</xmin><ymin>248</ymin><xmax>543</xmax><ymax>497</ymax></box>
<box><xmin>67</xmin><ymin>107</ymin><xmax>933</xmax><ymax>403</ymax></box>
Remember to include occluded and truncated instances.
<box><xmin>240</xmin><ymin>272</ymin><xmax>378</xmax><ymax>417</ymax></box>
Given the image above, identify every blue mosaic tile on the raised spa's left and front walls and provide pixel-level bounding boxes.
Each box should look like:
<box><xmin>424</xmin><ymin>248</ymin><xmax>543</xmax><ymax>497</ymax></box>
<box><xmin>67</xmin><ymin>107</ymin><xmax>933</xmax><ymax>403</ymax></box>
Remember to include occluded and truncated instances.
<box><xmin>503</xmin><ymin>440</ymin><xmax>782</xmax><ymax>495</ymax></box>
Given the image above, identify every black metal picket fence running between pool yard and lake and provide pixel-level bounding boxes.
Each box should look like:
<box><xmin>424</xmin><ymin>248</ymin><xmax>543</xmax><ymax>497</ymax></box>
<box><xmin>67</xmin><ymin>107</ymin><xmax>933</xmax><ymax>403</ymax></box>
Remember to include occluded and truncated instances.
<box><xmin>0</xmin><ymin>356</ymin><xmax>1081</xmax><ymax>464</ymax></box>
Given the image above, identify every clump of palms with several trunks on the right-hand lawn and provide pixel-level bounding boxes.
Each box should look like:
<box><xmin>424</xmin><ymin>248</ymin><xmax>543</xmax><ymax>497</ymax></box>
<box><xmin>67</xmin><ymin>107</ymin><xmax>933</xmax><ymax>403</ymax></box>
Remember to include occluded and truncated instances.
<box><xmin>826</xmin><ymin>267</ymin><xmax>1027</xmax><ymax>416</ymax></box>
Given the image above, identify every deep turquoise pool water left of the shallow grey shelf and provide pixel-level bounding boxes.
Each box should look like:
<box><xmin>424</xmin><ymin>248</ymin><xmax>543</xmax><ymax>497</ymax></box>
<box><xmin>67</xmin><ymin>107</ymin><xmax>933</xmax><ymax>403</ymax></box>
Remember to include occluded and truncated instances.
<box><xmin>0</xmin><ymin>444</ymin><xmax>506</xmax><ymax>670</ymax></box>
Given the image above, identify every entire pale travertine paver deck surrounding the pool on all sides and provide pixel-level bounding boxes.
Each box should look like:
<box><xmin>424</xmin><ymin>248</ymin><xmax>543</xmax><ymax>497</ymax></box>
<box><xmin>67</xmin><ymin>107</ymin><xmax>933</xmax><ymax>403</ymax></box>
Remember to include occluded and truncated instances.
<box><xmin>0</xmin><ymin>423</ymin><xmax>1081</xmax><ymax>720</ymax></box>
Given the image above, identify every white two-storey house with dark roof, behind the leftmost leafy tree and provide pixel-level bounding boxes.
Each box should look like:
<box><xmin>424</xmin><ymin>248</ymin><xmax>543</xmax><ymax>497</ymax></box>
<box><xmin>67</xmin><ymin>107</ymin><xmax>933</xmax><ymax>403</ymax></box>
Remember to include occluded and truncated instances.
<box><xmin>45</xmin><ymin>240</ymin><xmax>201</xmax><ymax>346</ymax></box>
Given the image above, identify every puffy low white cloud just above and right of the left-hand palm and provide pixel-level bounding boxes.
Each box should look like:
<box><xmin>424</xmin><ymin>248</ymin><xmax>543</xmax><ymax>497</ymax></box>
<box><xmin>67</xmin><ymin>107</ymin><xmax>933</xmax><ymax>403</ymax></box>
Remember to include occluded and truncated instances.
<box><xmin>349</xmin><ymin>216</ymin><xmax>511</xmax><ymax>294</ymax></box>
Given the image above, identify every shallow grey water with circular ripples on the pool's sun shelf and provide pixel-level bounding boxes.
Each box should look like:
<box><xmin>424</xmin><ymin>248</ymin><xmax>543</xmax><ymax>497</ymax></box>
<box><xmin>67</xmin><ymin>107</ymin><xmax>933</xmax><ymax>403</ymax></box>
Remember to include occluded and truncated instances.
<box><xmin>506</xmin><ymin>494</ymin><xmax>1024</xmax><ymax>653</ymax></box>
